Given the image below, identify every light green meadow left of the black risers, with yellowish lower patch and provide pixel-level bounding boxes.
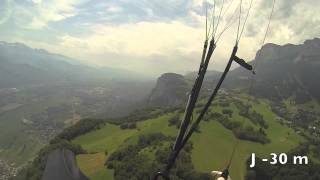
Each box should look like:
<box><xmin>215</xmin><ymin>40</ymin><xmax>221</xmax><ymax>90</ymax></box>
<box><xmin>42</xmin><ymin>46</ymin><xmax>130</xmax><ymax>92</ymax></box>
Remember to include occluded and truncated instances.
<box><xmin>73</xmin><ymin>114</ymin><xmax>176</xmax><ymax>180</ymax></box>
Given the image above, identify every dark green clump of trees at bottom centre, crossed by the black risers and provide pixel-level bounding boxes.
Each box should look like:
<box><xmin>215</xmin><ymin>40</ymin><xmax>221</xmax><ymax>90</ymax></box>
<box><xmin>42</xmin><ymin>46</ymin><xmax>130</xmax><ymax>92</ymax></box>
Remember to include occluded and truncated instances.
<box><xmin>106</xmin><ymin>133</ymin><xmax>211</xmax><ymax>180</ymax></box>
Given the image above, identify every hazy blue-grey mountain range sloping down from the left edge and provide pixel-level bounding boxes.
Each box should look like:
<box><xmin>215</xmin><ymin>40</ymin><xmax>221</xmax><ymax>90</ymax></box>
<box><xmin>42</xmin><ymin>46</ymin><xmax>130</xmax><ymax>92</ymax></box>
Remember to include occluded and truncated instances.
<box><xmin>0</xmin><ymin>42</ymin><xmax>142</xmax><ymax>88</ymax></box>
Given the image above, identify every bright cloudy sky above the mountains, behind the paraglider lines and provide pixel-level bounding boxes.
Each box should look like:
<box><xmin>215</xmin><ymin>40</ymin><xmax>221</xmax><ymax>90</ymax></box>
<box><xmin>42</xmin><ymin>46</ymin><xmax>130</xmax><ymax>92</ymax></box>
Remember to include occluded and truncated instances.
<box><xmin>0</xmin><ymin>0</ymin><xmax>320</xmax><ymax>75</ymax></box>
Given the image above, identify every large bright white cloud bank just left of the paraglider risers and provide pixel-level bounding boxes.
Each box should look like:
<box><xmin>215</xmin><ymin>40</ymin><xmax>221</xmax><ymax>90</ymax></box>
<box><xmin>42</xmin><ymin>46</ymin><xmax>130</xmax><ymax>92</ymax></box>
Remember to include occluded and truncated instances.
<box><xmin>58</xmin><ymin>21</ymin><xmax>203</xmax><ymax>57</ymax></box>
